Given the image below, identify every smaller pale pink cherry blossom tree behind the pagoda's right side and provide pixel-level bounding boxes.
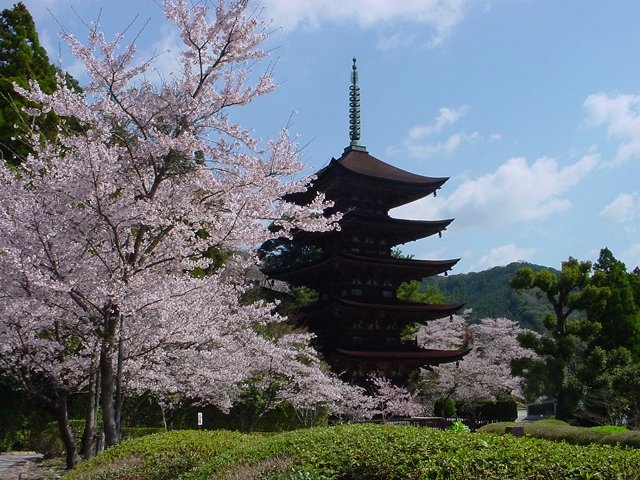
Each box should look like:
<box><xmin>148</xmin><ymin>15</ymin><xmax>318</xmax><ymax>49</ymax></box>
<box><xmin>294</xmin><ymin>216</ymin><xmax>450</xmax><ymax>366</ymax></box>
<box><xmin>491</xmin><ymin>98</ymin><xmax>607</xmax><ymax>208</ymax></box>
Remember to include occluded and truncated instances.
<box><xmin>418</xmin><ymin>312</ymin><xmax>536</xmax><ymax>412</ymax></box>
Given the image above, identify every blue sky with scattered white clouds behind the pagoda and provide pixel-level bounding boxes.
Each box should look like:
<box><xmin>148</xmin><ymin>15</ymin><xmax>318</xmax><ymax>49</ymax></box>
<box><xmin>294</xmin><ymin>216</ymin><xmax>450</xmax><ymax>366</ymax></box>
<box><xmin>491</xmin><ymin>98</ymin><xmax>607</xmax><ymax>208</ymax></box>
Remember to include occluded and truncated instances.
<box><xmin>8</xmin><ymin>0</ymin><xmax>640</xmax><ymax>273</ymax></box>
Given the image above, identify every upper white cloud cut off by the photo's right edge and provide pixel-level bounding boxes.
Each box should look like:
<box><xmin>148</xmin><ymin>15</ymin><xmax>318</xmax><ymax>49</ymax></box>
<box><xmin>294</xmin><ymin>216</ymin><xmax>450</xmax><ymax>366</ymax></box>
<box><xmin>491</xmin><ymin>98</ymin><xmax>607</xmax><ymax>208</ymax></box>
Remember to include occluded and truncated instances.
<box><xmin>584</xmin><ymin>93</ymin><xmax>640</xmax><ymax>164</ymax></box>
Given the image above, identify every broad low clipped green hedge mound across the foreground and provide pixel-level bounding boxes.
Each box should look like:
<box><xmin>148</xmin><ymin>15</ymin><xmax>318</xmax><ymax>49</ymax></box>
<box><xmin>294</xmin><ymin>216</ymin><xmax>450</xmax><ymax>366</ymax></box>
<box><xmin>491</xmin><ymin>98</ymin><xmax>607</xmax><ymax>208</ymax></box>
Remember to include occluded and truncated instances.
<box><xmin>63</xmin><ymin>424</ymin><xmax>640</xmax><ymax>480</ymax></box>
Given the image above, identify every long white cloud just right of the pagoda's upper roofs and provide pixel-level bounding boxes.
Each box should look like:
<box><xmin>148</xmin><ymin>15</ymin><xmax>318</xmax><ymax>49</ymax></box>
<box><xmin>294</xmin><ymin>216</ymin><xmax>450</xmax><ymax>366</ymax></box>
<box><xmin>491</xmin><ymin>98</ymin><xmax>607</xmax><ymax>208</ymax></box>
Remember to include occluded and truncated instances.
<box><xmin>393</xmin><ymin>155</ymin><xmax>598</xmax><ymax>229</ymax></box>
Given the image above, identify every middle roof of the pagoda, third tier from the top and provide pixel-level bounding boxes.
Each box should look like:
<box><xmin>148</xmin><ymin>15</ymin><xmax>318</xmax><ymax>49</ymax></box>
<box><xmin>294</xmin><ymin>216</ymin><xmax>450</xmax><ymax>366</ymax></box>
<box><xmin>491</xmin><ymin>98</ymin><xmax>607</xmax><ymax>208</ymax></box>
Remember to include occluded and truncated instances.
<box><xmin>265</xmin><ymin>251</ymin><xmax>460</xmax><ymax>282</ymax></box>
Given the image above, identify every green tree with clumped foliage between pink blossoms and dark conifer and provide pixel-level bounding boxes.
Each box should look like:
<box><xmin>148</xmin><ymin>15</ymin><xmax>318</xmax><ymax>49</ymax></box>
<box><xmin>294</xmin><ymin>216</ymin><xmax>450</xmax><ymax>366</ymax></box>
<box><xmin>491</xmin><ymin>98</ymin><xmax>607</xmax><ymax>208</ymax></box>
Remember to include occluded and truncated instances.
<box><xmin>509</xmin><ymin>257</ymin><xmax>608</xmax><ymax>420</ymax></box>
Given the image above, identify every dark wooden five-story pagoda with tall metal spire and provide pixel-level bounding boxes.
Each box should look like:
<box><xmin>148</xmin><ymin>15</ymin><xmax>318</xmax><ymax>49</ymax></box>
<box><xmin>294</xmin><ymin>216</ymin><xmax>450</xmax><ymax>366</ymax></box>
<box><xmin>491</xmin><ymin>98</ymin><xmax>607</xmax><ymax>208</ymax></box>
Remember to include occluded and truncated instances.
<box><xmin>262</xmin><ymin>59</ymin><xmax>468</xmax><ymax>383</ymax></box>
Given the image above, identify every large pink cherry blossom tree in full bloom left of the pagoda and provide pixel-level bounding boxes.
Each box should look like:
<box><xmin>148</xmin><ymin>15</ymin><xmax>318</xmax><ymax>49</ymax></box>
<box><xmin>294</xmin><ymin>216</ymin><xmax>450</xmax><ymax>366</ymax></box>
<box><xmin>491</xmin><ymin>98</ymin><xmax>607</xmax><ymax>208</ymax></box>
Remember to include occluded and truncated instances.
<box><xmin>0</xmin><ymin>0</ymin><xmax>338</xmax><ymax>467</ymax></box>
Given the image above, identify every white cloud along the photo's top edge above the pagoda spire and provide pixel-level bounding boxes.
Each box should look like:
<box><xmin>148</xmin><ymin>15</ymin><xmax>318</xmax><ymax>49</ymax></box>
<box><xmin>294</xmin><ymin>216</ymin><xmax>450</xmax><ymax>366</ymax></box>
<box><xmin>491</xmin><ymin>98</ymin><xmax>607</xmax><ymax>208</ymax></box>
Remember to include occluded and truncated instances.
<box><xmin>262</xmin><ymin>0</ymin><xmax>471</xmax><ymax>45</ymax></box>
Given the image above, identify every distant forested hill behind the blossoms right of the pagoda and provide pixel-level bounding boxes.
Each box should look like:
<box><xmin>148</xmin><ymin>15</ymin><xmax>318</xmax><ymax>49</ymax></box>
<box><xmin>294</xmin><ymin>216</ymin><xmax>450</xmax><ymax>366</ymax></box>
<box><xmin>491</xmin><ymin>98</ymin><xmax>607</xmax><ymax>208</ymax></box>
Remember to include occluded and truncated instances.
<box><xmin>423</xmin><ymin>263</ymin><xmax>551</xmax><ymax>331</ymax></box>
